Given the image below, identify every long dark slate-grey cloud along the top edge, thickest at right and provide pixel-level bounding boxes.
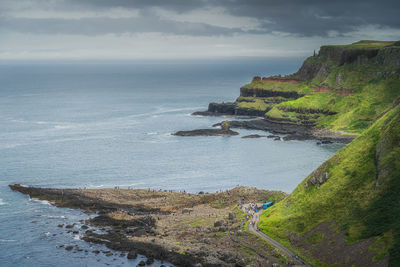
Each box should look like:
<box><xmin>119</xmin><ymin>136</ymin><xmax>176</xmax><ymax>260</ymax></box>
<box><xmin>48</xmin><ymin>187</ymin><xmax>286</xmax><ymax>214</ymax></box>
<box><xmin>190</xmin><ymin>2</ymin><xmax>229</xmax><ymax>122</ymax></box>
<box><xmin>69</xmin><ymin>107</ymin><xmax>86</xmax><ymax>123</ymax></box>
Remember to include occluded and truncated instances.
<box><xmin>66</xmin><ymin>0</ymin><xmax>400</xmax><ymax>36</ymax></box>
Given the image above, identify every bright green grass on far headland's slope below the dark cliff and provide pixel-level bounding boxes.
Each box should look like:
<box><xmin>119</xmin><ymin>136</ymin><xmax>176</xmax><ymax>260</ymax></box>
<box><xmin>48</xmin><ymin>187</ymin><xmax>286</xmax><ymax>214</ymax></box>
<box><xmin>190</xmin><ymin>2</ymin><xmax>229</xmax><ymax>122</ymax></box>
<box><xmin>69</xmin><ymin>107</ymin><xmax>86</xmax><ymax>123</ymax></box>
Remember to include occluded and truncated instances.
<box><xmin>266</xmin><ymin>59</ymin><xmax>400</xmax><ymax>134</ymax></box>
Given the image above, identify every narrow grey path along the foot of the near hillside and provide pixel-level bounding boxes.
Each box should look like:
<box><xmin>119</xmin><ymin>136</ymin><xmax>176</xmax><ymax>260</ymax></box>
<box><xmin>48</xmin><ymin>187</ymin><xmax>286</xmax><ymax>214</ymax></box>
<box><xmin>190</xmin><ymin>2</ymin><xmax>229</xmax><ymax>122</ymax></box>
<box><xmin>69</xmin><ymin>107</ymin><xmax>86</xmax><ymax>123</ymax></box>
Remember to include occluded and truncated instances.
<box><xmin>244</xmin><ymin>205</ymin><xmax>311</xmax><ymax>266</ymax></box>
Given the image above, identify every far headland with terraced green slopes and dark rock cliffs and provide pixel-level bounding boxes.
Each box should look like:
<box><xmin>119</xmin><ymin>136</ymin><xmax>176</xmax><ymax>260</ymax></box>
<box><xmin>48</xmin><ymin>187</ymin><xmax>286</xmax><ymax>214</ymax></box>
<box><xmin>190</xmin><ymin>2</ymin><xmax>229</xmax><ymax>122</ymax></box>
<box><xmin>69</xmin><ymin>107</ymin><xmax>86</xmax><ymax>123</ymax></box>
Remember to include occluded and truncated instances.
<box><xmin>235</xmin><ymin>41</ymin><xmax>400</xmax><ymax>134</ymax></box>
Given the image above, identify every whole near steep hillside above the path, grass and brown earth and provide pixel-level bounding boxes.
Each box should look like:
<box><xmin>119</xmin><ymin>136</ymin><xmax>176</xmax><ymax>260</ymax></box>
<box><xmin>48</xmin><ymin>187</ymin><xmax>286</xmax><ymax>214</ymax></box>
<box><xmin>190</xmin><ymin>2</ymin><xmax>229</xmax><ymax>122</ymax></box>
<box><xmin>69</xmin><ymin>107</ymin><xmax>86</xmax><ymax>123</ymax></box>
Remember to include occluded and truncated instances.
<box><xmin>259</xmin><ymin>100</ymin><xmax>400</xmax><ymax>266</ymax></box>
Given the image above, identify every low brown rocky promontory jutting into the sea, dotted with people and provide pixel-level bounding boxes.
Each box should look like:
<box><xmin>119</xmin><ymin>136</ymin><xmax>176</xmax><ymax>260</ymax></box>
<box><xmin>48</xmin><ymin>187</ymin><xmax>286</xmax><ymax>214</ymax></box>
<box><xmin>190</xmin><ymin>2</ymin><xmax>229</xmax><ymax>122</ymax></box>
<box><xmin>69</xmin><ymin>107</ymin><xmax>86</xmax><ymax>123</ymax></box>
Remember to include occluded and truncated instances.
<box><xmin>10</xmin><ymin>184</ymin><xmax>294</xmax><ymax>266</ymax></box>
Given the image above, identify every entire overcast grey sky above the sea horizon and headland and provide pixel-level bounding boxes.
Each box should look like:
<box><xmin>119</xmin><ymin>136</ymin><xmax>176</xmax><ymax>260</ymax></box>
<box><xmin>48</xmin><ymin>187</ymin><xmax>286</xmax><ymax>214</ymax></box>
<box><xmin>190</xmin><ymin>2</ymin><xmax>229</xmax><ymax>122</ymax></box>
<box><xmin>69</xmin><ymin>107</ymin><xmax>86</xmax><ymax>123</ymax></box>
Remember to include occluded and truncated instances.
<box><xmin>0</xmin><ymin>0</ymin><xmax>400</xmax><ymax>60</ymax></box>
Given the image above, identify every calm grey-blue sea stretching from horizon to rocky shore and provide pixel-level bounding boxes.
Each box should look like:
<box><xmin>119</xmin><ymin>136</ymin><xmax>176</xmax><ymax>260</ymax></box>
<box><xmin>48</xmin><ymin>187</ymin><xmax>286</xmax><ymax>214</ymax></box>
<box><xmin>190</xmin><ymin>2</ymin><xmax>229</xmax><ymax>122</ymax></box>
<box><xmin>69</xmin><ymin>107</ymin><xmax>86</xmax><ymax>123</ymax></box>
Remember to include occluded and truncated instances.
<box><xmin>0</xmin><ymin>58</ymin><xmax>342</xmax><ymax>266</ymax></box>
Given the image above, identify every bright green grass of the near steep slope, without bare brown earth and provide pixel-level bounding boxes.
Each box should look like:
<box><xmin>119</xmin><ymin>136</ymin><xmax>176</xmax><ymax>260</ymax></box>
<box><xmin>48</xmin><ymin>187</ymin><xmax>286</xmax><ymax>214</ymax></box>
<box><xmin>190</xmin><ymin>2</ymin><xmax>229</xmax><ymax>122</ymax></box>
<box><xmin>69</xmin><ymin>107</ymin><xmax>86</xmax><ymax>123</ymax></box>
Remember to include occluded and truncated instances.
<box><xmin>259</xmin><ymin>102</ymin><xmax>400</xmax><ymax>266</ymax></box>
